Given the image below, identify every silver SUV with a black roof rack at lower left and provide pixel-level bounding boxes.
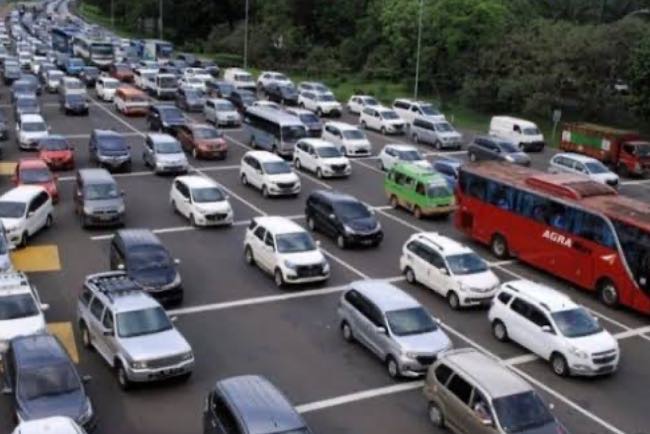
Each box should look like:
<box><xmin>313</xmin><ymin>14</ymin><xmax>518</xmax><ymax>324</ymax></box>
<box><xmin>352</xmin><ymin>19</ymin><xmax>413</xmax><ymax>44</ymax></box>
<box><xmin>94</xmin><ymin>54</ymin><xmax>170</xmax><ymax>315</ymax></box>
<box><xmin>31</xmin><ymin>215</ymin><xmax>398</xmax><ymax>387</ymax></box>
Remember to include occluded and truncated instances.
<box><xmin>77</xmin><ymin>272</ymin><xmax>194</xmax><ymax>390</ymax></box>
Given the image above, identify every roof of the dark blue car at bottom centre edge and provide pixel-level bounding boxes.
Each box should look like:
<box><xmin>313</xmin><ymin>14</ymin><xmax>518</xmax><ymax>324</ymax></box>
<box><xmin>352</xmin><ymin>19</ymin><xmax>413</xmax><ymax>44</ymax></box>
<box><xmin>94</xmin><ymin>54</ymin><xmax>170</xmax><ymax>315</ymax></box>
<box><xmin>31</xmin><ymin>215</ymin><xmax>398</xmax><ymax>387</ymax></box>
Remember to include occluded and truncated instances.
<box><xmin>216</xmin><ymin>375</ymin><xmax>305</xmax><ymax>434</ymax></box>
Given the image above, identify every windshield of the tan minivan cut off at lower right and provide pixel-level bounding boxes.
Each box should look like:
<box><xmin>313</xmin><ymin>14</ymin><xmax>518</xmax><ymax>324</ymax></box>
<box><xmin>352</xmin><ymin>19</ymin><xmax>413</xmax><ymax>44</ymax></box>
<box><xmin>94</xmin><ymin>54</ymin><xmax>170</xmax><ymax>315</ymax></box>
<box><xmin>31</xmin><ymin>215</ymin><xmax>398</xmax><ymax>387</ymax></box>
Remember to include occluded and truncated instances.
<box><xmin>492</xmin><ymin>391</ymin><xmax>554</xmax><ymax>433</ymax></box>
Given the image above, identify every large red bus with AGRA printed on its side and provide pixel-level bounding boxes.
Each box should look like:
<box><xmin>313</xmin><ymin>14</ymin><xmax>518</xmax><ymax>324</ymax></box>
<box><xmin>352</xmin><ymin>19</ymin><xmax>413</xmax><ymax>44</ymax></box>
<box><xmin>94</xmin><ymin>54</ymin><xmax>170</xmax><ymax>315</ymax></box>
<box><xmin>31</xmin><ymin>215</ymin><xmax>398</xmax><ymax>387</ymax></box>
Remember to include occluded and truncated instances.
<box><xmin>454</xmin><ymin>161</ymin><xmax>650</xmax><ymax>314</ymax></box>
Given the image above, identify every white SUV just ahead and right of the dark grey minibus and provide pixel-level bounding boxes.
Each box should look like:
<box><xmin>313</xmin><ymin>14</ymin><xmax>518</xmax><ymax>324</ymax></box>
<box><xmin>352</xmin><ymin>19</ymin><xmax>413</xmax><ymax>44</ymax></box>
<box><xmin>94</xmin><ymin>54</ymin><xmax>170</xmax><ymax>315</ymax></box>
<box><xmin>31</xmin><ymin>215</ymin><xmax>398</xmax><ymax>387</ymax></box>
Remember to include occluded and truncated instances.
<box><xmin>293</xmin><ymin>139</ymin><xmax>352</xmax><ymax>178</ymax></box>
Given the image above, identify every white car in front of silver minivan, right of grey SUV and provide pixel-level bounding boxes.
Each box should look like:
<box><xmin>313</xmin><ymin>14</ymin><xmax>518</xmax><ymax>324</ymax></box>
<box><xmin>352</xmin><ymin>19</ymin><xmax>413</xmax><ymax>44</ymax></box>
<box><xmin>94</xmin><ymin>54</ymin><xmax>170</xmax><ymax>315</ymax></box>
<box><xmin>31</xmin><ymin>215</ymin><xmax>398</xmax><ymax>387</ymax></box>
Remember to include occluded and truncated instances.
<box><xmin>169</xmin><ymin>175</ymin><xmax>233</xmax><ymax>226</ymax></box>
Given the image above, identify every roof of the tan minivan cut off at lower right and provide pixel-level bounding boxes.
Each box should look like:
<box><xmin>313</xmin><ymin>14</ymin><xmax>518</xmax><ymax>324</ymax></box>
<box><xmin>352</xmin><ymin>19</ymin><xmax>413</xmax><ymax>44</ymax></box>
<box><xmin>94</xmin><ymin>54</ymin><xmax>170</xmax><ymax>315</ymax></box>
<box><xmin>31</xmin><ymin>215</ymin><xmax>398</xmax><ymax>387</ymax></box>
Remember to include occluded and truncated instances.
<box><xmin>438</xmin><ymin>348</ymin><xmax>532</xmax><ymax>399</ymax></box>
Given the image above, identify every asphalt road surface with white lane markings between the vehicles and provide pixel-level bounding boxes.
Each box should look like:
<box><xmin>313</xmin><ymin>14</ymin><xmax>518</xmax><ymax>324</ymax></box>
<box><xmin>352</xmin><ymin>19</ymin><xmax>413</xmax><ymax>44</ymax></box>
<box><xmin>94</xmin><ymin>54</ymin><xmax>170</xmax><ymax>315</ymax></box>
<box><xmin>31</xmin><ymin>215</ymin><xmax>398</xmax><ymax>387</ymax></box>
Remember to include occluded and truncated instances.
<box><xmin>0</xmin><ymin>27</ymin><xmax>650</xmax><ymax>434</ymax></box>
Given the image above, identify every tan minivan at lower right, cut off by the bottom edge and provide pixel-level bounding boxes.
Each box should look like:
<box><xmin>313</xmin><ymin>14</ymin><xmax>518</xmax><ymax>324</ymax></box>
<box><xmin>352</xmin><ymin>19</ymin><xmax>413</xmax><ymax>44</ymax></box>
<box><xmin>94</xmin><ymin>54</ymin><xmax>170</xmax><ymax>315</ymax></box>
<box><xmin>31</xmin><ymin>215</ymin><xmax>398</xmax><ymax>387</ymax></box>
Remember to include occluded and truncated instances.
<box><xmin>424</xmin><ymin>348</ymin><xmax>568</xmax><ymax>434</ymax></box>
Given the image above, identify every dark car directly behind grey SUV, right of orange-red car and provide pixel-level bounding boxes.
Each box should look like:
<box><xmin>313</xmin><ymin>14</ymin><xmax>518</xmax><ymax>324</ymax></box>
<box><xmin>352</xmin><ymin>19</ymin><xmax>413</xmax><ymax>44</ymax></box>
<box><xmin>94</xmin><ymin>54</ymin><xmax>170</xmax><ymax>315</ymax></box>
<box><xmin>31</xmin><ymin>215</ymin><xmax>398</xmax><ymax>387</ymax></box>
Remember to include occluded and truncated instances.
<box><xmin>88</xmin><ymin>130</ymin><xmax>131</xmax><ymax>172</ymax></box>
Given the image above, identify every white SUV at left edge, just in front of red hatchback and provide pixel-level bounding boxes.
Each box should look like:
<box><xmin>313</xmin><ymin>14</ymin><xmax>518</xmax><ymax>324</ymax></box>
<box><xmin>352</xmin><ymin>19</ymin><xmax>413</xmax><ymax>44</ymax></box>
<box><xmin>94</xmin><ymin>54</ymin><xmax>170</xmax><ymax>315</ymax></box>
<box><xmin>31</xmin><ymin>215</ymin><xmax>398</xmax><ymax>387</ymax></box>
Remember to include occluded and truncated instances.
<box><xmin>0</xmin><ymin>185</ymin><xmax>54</xmax><ymax>247</ymax></box>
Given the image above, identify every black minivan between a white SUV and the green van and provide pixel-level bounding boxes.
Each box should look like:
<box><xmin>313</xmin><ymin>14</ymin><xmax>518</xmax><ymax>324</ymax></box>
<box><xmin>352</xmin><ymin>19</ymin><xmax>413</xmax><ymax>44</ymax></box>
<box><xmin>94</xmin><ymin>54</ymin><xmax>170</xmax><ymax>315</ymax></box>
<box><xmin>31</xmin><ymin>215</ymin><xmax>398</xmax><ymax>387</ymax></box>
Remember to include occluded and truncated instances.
<box><xmin>305</xmin><ymin>190</ymin><xmax>384</xmax><ymax>249</ymax></box>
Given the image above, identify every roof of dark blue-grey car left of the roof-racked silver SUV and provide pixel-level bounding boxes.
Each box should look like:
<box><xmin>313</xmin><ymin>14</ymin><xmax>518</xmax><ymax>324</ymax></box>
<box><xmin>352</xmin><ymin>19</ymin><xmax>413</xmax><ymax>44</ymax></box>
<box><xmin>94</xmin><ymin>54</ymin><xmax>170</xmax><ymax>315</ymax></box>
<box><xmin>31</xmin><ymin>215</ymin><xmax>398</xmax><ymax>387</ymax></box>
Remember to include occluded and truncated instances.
<box><xmin>11</xmin><ymin>333</ymin><xmax>70</xmax><ymax>368</ymax></box>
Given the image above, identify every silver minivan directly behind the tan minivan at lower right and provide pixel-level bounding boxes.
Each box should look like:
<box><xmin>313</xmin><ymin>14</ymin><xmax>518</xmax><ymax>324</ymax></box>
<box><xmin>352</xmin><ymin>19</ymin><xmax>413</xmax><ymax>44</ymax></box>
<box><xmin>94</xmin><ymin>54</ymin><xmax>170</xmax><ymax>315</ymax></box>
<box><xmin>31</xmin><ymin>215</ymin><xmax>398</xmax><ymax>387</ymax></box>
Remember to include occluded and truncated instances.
<box><xmin>338</xmin><ymin>280</ymin><xmax>452</xmax><ymax>378</ymax></box>
